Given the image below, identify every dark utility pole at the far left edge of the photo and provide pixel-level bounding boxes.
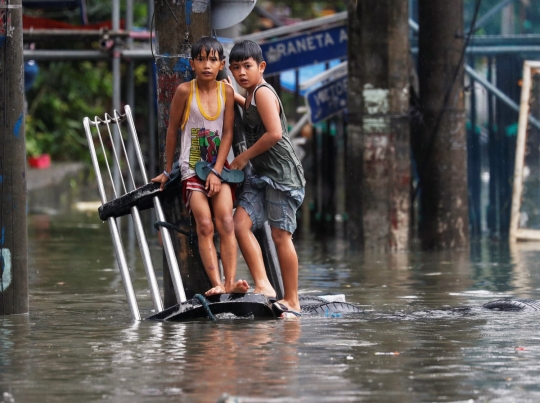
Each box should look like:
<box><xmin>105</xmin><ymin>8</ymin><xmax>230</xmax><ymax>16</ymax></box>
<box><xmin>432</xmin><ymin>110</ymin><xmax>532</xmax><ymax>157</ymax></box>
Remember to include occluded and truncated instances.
<box><xmin>0</xmin><ymin>0</ymin><xmax>28</xmax><ymax>315</ymax></box>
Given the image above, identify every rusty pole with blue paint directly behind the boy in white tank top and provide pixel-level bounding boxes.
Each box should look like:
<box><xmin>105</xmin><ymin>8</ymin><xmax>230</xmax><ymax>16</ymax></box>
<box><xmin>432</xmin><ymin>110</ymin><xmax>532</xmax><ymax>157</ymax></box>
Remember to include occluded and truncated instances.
<box><xmin>154</xmin><ymin>0</ymin><xmax>211</xmax><ymax>307</ymax></box>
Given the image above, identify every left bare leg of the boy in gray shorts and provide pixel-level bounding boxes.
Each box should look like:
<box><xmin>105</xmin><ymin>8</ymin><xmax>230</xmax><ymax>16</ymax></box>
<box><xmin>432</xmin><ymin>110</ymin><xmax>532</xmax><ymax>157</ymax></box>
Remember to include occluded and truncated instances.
<box><xmin>234</xmin><ymin>207</ymin><xmax>276</xmax><ymax>297</ymax></box>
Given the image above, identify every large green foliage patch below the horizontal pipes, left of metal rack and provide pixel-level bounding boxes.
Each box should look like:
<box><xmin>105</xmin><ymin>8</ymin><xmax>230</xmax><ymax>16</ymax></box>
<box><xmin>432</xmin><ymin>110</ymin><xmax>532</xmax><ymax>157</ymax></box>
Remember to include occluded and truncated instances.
<box><xmin>26</xmin><ymin>61</ymin><xmax>112</xmax><ymax>161</ymax></box>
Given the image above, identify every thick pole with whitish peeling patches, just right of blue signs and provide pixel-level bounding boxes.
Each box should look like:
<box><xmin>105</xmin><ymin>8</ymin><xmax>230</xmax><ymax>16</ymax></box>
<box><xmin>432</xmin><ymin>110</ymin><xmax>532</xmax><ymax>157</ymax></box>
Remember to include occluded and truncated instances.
<box><xmin>345</xmin><ymin>0</ymin><xmax>411</xmax><ymax>251</ymax></box>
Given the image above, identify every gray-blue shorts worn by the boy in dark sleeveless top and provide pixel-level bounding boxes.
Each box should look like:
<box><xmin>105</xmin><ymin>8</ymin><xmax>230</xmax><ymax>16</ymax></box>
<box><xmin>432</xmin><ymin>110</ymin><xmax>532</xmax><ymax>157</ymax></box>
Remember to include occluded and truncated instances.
<box><xmin>236</xmin><ymin>177</ymin><xmax>305</xmax><ymax>234</ymax></box>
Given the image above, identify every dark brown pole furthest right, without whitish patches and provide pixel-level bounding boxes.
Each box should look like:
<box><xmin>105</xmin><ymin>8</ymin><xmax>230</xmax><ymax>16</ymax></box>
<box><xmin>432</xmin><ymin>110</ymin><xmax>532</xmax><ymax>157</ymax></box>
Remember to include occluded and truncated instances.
<box><xmin>415</xmin><ymin>0</ymin><xmax>469</xmax><ymax>249</ymax></box>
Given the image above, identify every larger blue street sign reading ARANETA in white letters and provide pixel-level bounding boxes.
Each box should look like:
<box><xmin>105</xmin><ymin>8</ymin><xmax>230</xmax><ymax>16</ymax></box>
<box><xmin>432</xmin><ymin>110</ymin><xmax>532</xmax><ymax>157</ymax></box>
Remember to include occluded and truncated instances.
<box><xmin>261</xmin><ymin>25</ymin><xmax>348</xmax><ymax>75</ymax></box>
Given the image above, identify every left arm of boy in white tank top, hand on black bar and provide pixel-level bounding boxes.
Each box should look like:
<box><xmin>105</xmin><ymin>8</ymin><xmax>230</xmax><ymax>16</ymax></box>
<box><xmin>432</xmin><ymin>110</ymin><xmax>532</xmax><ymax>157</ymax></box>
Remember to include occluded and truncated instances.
<box><xmin>151</xmin><ymin>82</ymin><xmax>191</xmax><ymax>190</ymax></box>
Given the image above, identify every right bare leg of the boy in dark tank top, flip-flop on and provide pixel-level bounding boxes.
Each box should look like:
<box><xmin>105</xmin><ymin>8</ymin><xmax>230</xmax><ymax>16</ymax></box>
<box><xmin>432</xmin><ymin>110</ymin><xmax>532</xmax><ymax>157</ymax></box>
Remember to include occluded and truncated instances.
<box><xmin>271</xmin><ymin>227</ymin><xmax>300</xmax><ymax>311</ymax></box>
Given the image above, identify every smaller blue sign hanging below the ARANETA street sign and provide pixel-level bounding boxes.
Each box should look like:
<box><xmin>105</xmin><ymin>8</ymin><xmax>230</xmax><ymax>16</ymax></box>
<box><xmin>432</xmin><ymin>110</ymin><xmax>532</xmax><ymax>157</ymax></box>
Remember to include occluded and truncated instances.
<box><xmin>306</xmin><ymin>75</ymin><xmax>347</xmax><ymax>123</ymax></box>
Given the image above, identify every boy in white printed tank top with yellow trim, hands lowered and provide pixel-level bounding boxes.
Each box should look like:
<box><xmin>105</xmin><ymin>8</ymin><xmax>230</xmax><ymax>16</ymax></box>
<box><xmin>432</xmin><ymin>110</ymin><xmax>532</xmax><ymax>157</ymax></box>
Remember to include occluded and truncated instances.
<box><xmin>152</xmin><ymin>37</ymin><xmax>249</xmax><ymax>296</ymax></box>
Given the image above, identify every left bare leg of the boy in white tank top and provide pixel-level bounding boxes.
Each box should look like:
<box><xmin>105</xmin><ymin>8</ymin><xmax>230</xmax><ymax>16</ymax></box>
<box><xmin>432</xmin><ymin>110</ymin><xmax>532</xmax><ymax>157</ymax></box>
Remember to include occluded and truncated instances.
<box><xmin>190</xmin><ymin>191</ymin><xmax>225</xmax><ymax>294</ymax></box>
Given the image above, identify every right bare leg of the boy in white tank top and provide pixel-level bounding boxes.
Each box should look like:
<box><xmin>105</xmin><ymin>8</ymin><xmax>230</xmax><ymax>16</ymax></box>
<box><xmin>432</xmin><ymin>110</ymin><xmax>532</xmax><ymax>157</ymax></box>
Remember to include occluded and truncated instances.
<box><xmin>206</xmin><ymin>183</ymin><xmax>249</xmax><ymax>295</ymax></box>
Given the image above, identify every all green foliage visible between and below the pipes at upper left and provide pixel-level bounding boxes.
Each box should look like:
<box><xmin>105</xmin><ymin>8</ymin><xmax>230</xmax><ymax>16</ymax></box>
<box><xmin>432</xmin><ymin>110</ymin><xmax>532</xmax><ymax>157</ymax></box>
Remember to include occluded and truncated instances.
<box><xmin>25</xmin><ymin>0</ymin><xmax>148</xmax><ymax>161</ymax></box>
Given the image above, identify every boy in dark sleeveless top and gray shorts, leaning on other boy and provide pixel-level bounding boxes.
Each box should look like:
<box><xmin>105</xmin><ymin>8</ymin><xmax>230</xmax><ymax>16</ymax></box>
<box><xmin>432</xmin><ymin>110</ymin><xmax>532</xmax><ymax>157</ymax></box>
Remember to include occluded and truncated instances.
<box><xmin>229</xmin><ymin>41</ymin><xmax>305</xmax><ymax>316</ymax></box>
